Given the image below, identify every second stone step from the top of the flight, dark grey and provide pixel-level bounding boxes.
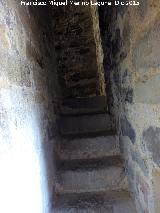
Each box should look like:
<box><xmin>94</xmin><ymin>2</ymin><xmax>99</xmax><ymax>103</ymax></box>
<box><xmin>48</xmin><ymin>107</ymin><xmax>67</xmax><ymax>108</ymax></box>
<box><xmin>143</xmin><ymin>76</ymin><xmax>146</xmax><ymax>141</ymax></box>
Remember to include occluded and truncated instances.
<box><xmin>59</xmin><ymin>114</ymin><xmax>113</xmax><ymax>137</ymax></box>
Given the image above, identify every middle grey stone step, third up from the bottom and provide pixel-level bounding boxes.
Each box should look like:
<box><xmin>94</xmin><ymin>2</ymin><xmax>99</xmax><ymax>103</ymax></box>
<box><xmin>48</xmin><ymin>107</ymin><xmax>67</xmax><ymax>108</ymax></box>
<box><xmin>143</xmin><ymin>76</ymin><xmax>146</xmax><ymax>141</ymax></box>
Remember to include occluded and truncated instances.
<box><xmin>59</xmin><ymin>136</ymin><xmax>120</xmax><ymax>160</ymax></box>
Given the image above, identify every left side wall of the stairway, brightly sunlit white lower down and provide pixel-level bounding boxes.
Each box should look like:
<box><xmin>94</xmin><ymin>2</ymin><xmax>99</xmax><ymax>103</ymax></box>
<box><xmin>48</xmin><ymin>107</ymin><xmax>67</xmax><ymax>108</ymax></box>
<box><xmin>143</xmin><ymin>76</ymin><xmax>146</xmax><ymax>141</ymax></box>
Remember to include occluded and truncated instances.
<box><xmin>0</xmin><ymin>0</ymin><xmax>57</xmax><ymax>213</ymax></box>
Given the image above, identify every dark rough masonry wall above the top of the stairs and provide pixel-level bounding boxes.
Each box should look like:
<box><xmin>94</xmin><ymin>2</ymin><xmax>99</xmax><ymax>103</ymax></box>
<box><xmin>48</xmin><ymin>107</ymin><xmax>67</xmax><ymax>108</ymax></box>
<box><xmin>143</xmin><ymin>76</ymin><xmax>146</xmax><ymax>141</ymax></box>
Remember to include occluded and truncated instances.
<box><xmin>53</xmin><ymin>5</ymin><xmax>105</xmax><ymax>98</ymax></box>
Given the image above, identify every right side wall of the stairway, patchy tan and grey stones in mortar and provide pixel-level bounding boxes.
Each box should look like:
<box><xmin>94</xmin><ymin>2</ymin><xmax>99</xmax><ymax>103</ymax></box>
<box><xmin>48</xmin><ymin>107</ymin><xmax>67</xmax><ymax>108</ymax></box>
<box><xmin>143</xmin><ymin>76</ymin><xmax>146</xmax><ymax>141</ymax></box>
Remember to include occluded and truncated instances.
<box><xmin>99</xmin><ymin>0</ymin><xmax>160</xmax><ymax>213</ymax></box>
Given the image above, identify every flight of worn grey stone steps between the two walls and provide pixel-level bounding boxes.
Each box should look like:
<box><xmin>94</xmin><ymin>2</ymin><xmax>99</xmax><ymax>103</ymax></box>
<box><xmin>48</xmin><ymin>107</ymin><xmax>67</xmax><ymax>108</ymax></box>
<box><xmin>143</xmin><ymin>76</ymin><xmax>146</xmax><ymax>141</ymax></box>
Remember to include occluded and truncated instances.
<box><xmin>54</xmin><ymin>97</ymin><xmax>136</xmax><ymax>213</ymax></box>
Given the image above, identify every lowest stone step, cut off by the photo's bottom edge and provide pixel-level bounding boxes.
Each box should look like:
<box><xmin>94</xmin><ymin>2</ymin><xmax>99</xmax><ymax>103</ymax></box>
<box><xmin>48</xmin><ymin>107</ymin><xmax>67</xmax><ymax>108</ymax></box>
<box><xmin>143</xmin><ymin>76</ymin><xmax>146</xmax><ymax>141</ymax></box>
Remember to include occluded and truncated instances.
<box><xmin>54</xmin><ymin>191</ymin><xmax>136</xmax><ymax>213</ymax></box>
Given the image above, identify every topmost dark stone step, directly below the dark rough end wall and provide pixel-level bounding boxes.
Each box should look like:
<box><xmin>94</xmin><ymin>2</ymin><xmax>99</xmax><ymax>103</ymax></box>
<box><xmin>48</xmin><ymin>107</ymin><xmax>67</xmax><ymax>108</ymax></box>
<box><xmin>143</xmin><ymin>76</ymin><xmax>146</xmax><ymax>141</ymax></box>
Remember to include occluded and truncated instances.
<box><xmin>60</xmin><ymin>96</ymin><xmax>107</xmax><ymax>115</ymax></box>
